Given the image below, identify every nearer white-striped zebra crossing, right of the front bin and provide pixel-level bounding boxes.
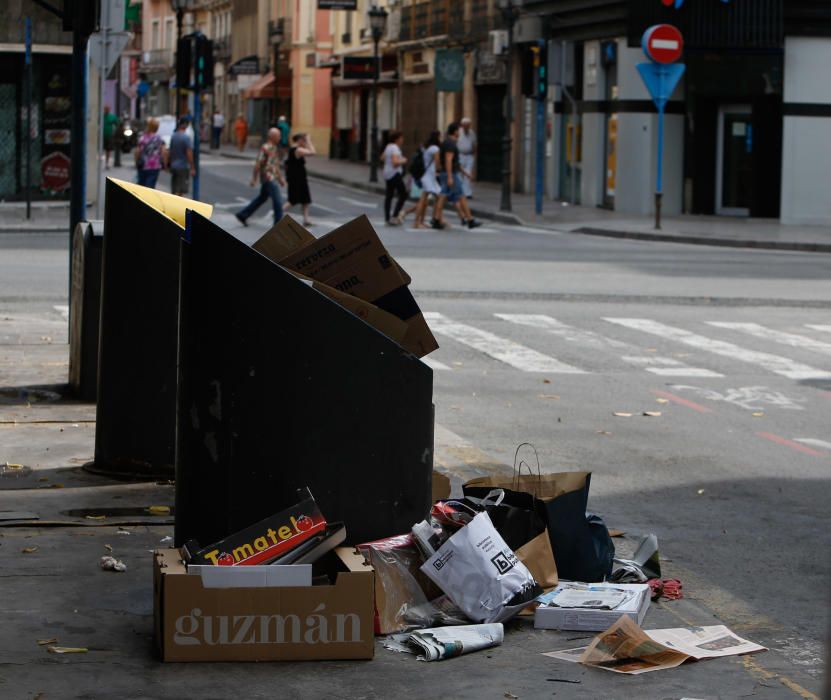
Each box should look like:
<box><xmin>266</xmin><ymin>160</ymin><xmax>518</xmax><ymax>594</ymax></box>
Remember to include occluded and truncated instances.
<box><xmin>424</xmin><ymin>311</ymin><xmax>831</xmax><ymax>380</ymax></box>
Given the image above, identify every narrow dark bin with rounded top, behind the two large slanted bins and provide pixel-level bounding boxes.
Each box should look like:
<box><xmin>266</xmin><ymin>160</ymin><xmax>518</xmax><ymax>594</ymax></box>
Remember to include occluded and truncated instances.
<box><xmin>69</xmin><ymin>221</ymin><xmax>104</xmax><ymax>401</ymax></box>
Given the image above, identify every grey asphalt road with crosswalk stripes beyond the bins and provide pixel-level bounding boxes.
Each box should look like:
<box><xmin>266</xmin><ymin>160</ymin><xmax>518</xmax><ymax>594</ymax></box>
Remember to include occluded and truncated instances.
<box><xmin>0</xmin><ymin>158</ymin><xmax>831</xmax><ymax>678</ymax></box>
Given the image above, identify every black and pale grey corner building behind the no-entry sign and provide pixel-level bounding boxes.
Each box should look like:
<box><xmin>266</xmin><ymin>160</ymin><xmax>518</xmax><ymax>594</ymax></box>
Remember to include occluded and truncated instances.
<box><xmin>520</xmin><ymin>0</ymin><xmax>831</xmax><ymax>225</ymax></box>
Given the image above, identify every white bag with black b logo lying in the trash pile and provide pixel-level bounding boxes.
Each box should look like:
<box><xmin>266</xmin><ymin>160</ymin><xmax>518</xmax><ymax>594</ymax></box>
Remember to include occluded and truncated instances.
<box><xmin>421</xmin><ymin>513</ymin><xmax>542</xmax><ymax>622</ymax></box>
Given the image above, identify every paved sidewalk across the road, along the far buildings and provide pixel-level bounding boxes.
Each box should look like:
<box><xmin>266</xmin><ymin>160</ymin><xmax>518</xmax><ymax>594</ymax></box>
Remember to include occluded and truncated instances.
<box><xmin>218</xmin><ymin>147</ymin><xmax>831</xmax><ymax>253</ymax></box>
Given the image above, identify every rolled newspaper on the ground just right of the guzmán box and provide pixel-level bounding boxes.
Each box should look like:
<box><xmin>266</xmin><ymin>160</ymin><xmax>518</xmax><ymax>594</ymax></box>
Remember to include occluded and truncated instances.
<box><xmin>384</xmin><ymin>622</ymin><xmax>505</xmax><ymax>661</ymax></box>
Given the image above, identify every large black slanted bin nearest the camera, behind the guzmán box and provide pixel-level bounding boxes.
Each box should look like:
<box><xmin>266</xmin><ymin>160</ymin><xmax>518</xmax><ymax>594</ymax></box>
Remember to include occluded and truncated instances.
<box><xmin>174</xmin><ymin>212</ymin><xmax>433</xmax><ymax>545</ymax></box>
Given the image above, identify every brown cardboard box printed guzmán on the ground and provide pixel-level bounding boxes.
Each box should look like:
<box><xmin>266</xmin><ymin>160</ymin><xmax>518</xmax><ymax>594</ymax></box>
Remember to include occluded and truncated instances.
<box><xmin>153</xmin><ymin>547</ymin><xmax>375</xmax><ymax>661</ymax></box>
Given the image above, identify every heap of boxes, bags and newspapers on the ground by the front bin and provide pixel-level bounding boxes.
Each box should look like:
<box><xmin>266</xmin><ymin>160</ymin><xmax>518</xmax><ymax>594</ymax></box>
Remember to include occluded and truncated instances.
<box><xmin>154</xmin><ymin>440</ymin><xmax>764</xmax><ymax>674</ymax></box>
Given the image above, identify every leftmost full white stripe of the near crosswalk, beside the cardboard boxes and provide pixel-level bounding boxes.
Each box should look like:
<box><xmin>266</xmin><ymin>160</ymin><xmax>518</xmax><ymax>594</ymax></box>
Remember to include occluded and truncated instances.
<box><xmin>424</xmin><ymin>311</ymin><xmax>586</xmax><ymax>374</ymax></box>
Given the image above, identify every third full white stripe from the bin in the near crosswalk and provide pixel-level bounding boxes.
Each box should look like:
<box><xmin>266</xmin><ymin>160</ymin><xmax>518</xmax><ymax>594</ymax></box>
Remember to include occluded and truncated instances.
<box><xmin>604</xmin><ymin>318</ymin><xmax>831</xmax><ymax>379</ymax></box>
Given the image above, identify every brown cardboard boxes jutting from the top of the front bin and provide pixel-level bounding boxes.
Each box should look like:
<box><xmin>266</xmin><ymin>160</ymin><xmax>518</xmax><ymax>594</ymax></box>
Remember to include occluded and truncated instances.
<box><xmin>253</xmin><ymin>216</ymin><xmax>438</xmax><ymax>357</ymax></box>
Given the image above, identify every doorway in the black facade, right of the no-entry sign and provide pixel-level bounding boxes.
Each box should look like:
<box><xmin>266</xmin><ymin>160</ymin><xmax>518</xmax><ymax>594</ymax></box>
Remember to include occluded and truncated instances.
<box><xmin>716</xmin><ymin>105</ymin><xmax>753</xmax><ymax>216</ymax></box>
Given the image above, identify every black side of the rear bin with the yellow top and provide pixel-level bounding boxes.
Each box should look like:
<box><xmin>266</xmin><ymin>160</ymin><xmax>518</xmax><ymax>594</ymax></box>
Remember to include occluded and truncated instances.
<box><xmin>86</xmin><ymin>180</ymin><xmax>183</xmax><ymax>479</ymax></box>
